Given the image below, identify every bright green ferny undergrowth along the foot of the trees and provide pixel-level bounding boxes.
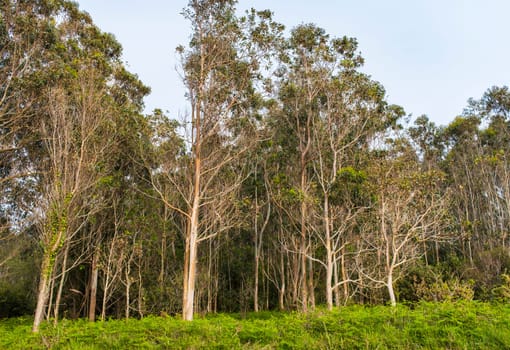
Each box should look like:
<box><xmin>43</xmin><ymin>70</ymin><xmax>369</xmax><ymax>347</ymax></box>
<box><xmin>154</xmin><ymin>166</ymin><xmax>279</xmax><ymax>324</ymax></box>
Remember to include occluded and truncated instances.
<box><xmin>0</xmin><ymin>302</ymin><xmax>510</xmax><ymax>349</ymax></box>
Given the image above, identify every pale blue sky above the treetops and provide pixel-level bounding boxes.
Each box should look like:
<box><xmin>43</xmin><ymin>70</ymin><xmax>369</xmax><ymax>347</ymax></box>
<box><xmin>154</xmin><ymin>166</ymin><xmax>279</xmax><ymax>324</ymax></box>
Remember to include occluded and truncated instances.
<box><xmin>77</xmin><ymin>0</ymin><xmax>510</xmax><ymax>125</ymax></box>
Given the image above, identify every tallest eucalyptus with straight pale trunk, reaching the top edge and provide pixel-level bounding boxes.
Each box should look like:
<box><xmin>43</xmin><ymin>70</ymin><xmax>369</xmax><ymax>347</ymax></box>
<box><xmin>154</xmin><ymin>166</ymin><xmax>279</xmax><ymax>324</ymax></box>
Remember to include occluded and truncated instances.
<box><xmin>153</xmin><ymin>0</ymin><xmax>281</xmax><ymax>320</ymax></box>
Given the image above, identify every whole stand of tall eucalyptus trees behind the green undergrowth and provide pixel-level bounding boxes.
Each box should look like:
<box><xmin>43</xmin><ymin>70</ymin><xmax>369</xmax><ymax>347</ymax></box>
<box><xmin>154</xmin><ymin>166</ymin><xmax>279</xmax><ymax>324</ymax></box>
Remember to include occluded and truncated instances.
<box><xmin>0</xmin><ymin>0</ymin><xmax>510</xmax><ymax>332</ymax></box>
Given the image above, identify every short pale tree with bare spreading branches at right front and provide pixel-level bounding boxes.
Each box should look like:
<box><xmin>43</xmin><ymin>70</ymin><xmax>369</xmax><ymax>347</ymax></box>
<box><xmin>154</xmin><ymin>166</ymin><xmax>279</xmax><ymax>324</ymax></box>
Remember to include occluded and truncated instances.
<box><xmin>358</xmin><ymin>138</ymin><xmax>448</xmax><ymax>306</ymax></box>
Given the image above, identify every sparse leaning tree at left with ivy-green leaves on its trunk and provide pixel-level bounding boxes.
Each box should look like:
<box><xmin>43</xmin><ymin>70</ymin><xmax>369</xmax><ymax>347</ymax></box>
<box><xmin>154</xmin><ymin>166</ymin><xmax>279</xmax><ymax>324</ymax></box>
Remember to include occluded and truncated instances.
<box><xmin>33</xmin><ymin>71</ymin><xmax>116</xmax><ymax>332</ymax></box>
